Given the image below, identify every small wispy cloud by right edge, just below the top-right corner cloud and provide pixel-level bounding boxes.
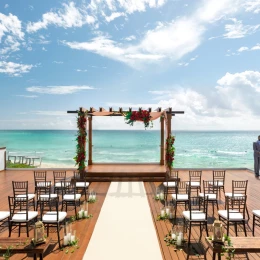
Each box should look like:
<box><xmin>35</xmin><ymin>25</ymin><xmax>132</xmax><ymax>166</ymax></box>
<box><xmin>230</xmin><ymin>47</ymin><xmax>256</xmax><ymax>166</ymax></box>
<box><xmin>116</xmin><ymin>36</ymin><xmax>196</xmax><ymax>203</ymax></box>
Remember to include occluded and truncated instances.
<box><xmin>223</xmin><ymin>18</ymin><xmax>260</xmax><ymax>39</ymax></box>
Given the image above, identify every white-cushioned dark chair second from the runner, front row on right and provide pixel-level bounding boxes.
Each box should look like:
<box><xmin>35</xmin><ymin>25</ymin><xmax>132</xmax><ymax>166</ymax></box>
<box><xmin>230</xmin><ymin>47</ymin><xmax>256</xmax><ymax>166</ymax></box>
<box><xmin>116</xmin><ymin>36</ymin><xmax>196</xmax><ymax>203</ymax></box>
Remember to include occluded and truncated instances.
<box><xmin>218</xmin><ymin>195</ymin><xmax>247</xmax><ymax>236</ymax></box>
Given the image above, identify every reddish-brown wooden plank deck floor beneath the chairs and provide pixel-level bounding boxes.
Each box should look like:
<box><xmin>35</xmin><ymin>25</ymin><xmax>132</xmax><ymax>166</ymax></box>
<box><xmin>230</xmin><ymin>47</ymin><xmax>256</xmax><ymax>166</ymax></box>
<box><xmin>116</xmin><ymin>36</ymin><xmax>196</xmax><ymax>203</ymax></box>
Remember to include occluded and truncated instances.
<box><xmin>0</xmin><ymin>170</ymin><xmax>260</xmax><ymax>260</ymax></box>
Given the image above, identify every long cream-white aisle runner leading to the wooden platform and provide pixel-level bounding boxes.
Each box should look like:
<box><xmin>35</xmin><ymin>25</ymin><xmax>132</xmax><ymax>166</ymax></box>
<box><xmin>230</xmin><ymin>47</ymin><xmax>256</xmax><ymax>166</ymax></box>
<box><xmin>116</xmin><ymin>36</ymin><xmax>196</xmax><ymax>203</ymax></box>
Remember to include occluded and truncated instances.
<box><xmin>83</xmin><ymin>182</ymin><xmax>162</xmax><ymax>260</ymax></box>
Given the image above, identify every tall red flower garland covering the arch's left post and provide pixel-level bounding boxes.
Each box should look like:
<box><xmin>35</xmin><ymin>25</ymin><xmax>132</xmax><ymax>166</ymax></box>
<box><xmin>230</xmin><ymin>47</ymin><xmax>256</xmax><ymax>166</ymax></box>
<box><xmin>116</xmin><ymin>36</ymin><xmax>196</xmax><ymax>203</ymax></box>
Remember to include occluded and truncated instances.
<box><xmin>74</xmin><ymin>111</ymin><xmax>87</xmax><ymax>172</ymax></box>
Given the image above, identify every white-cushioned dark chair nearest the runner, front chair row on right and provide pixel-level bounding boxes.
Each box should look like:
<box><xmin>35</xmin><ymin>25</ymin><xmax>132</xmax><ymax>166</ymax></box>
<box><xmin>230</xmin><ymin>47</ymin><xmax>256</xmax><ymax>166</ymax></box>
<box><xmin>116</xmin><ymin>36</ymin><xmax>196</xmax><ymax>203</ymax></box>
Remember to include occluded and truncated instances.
<box><xmin>182</xmin><ymin>192</ymin><xmax>209</xmax><ymax>245</ymax></box>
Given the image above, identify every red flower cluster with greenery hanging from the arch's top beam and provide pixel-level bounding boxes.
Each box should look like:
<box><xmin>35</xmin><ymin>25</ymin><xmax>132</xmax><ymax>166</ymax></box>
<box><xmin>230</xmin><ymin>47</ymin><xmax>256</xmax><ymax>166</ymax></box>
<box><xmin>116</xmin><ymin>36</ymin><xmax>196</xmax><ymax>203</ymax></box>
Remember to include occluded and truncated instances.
<box><xmin>125</xmin><ymin>110</ymin><xmax>153</xmax><ymax>128</ymax></box>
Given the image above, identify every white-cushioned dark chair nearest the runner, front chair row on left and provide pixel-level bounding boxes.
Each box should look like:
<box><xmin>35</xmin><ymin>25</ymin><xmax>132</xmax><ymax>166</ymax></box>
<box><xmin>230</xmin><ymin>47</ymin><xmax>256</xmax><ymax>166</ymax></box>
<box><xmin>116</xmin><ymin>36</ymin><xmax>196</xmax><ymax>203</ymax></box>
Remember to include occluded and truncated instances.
<box><xmin>39</xmin><ymin>197</ymin><xmax>67</xmax><ymax>249</ymax></box>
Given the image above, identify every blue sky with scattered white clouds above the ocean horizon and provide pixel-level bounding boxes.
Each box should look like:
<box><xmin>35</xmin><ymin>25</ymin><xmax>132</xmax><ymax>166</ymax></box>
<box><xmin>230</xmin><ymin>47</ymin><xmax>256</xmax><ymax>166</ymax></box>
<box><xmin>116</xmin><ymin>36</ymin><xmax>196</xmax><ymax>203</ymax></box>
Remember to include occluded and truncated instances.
<box><xmin>0</xmin><ymin>0</ymin><xmax>260</xmax><ymax>130</ymax></box>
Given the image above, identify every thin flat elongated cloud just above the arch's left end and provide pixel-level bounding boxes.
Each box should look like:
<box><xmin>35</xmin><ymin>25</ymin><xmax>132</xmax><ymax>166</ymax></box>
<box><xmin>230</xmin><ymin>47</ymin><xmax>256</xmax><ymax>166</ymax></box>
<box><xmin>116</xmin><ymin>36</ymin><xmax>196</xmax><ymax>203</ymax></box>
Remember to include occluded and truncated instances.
<box><xmin>26</xmin><ymin>86</ymin><xmax>94</xmax><ymax>95</ymax></box>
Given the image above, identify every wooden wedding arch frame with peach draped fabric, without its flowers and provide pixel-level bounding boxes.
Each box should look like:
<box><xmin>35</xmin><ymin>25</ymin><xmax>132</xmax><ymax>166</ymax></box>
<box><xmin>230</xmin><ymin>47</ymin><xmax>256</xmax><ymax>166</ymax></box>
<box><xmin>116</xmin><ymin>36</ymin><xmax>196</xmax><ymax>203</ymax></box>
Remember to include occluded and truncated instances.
<box><xmin>67</xmin><ymin>107</ymin><xmax>184</xmax><ymax>165</ymax></box>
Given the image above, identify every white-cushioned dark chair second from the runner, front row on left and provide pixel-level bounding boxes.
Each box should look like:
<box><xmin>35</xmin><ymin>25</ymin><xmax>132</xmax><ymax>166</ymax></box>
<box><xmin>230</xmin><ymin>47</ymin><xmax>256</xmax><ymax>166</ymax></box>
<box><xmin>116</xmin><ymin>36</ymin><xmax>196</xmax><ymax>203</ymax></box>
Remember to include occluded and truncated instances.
<box><xmin>8</xmin><ymin>195</ymin><xmax>38</xmax><ymax>237</ymax></box>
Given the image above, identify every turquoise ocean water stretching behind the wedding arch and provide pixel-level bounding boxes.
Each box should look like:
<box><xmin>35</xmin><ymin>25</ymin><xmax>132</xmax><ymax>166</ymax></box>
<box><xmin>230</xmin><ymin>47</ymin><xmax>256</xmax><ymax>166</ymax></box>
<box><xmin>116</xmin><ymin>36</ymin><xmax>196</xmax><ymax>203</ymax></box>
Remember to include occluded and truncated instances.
<box><xmin>0</xmin><ymin>130</ymin><xmax>260</xmax><ymax>169</ymax></box>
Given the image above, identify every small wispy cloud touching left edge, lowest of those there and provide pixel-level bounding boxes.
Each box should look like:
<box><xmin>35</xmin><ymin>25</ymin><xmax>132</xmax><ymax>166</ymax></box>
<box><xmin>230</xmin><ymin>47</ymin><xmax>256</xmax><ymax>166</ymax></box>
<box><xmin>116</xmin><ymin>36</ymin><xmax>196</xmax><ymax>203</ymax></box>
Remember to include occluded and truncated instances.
<box><xmin>0</xmin><ymin>61</ymin><xmax>34</xmax><ymax>77</ymax></box>
